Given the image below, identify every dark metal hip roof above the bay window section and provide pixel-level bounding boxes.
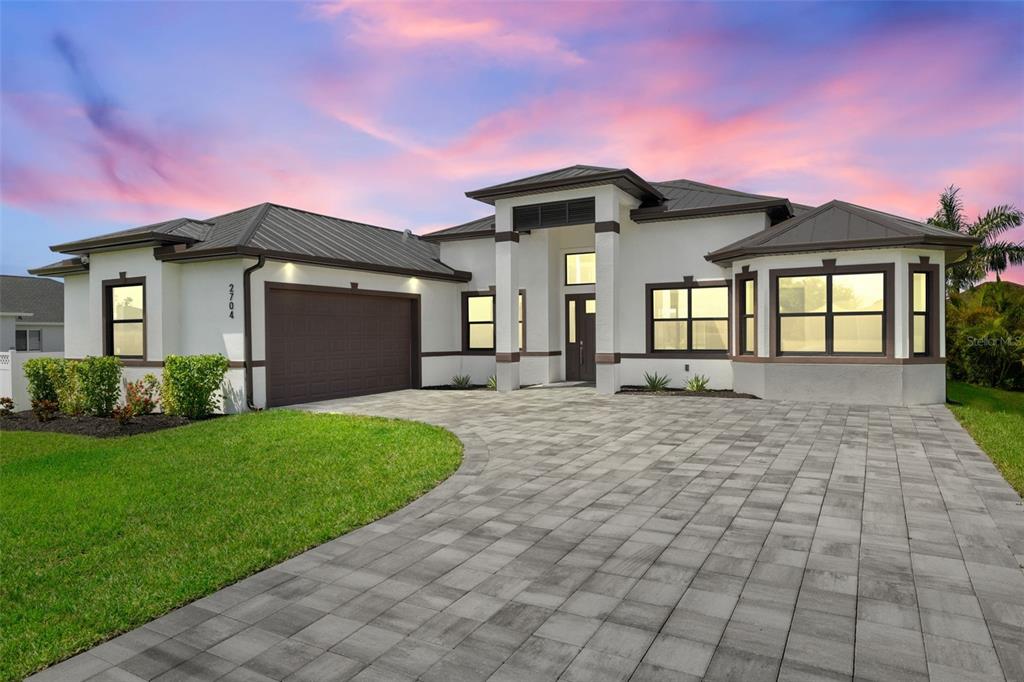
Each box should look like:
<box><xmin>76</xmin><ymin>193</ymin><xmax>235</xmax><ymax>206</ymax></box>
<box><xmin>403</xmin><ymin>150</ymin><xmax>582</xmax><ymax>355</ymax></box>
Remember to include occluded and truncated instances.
<box><xmin>706</xmin><ymin>200</ymin><xmax>978</xmax><ymax>263</ymax></box>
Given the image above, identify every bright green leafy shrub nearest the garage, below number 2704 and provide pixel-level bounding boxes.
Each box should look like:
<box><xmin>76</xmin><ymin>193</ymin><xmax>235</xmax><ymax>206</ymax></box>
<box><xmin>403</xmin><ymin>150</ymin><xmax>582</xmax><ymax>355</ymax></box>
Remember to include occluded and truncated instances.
<box><xmin>160</xmin><ymin>355</ymin><xmax>228</xmax><ymax>419</ymax></box>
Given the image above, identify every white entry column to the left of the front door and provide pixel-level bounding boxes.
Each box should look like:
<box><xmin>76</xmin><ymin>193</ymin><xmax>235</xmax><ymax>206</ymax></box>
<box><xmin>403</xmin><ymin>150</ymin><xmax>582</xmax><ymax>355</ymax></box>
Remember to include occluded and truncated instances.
<box><xmin>495</xmin><ymin>204</ymin><xmax>519</xmax><ymax>393</ymax></box>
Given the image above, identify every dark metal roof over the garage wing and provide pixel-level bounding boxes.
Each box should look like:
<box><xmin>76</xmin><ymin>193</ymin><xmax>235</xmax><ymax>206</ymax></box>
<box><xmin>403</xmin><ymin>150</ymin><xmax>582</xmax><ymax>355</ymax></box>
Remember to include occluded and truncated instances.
<box><xmin>34</xmin><ymin>203</ymin><xmax>470</xmax><ymax>282</ymax></box>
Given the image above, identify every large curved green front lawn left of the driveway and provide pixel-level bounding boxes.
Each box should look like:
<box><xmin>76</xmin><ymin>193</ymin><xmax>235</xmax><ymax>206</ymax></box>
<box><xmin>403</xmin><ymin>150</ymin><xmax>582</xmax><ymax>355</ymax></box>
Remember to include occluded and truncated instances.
<box><xmin>0</xmin><ymin>411</ymin><xmax>462</xmax><ymax>680</ymax></box>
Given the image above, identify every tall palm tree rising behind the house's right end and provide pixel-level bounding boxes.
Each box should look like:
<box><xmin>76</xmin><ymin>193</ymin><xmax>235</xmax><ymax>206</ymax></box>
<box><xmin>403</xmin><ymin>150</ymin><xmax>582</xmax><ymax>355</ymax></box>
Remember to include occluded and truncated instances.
<box><xmin>928</xmin><ymin>184</ymin><xmax>1024</xmax><ymax>291</ymax></box>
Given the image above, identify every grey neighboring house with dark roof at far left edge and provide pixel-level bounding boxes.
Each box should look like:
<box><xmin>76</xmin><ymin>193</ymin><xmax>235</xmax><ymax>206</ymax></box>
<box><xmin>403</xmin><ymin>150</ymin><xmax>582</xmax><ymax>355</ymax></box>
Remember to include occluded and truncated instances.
<box><xmin>0</xmin><ymin>274</ymin><xmax>63</xmax><ymax>352</ymax></box>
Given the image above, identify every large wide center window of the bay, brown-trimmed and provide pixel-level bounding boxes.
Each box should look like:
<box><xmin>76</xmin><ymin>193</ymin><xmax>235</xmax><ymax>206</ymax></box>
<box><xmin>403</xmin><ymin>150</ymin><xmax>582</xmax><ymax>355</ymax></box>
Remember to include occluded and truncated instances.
<box><xmin>775</xmin><ymin>271</ymin><xmax>891</xmax><ymax>355</ymax></box>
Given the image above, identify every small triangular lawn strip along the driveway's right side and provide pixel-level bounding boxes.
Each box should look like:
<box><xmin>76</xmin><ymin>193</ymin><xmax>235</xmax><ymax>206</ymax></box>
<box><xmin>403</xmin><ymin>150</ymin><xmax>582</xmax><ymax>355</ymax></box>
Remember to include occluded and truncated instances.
<box><xmin>946</xmin><ymin>381</ymin><xmax>1024</xmax><ymax>496</ymax></box>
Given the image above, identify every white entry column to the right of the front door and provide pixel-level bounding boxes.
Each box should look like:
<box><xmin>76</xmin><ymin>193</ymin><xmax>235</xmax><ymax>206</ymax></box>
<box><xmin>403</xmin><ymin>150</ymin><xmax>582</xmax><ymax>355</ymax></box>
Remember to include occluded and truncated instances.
<box><xmin>594</xmin><ymin>219</ymin><xmax>622</xmax><ymax>393</ymax></box>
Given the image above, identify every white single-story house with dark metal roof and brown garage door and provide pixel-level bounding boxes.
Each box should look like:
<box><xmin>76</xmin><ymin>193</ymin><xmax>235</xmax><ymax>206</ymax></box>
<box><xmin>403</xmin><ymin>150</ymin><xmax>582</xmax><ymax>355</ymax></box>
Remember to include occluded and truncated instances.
<box><xmin>33</xmin><ymin>166</ymin><xmax>974</xmax><ymax>410</ymax></box>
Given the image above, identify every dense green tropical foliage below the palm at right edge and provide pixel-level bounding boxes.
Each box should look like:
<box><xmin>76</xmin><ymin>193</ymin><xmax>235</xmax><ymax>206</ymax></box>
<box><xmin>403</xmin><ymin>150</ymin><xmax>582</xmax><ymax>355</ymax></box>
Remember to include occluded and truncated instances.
<box><xmin>946</xmin><ymin>282</ymin><xmax>1024</xmax><ymax>390</ymax></box>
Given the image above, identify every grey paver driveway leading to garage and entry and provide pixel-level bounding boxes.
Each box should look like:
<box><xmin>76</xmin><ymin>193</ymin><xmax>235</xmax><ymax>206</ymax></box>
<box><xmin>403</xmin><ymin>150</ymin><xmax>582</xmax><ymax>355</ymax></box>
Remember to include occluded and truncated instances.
<box><xmin>40</xmin><ymin>387</ymin><xmax>1024</xmax><ymax>682</ymax></box>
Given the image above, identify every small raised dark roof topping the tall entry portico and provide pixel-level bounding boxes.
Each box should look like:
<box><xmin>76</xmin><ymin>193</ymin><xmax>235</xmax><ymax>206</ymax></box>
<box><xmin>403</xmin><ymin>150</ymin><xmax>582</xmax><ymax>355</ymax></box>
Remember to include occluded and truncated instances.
<box><xmin>466</xmin><ymin>165</ymin><xmax>665</xmax><ymax>205</ymax></box>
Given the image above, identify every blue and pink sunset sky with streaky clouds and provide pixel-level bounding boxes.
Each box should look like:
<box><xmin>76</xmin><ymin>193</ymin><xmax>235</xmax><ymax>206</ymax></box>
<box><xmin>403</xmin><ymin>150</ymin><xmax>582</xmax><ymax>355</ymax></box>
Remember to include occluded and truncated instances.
<box><xmin>0</xmin><ymin>1</ymin><xmax>1024</xmax><ymax>282</ymax></box>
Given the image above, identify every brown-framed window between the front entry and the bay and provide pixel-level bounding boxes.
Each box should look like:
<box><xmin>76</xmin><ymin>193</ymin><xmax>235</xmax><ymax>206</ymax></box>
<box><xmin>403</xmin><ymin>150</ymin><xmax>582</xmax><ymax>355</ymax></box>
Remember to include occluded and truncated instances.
<box><xmin>648</xmin><ymin>283</ymin><xmax>729</xmax><ymax>354</ymax></box>
